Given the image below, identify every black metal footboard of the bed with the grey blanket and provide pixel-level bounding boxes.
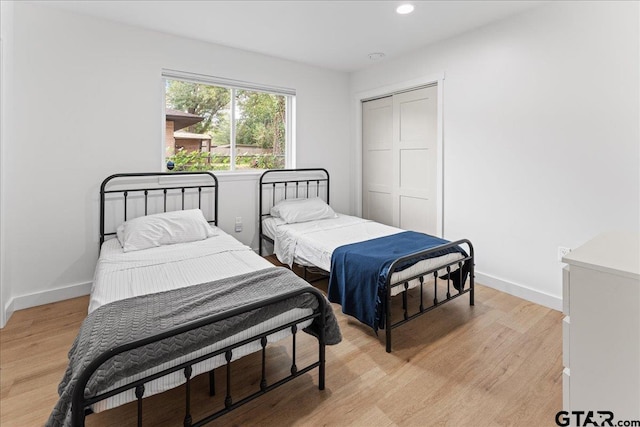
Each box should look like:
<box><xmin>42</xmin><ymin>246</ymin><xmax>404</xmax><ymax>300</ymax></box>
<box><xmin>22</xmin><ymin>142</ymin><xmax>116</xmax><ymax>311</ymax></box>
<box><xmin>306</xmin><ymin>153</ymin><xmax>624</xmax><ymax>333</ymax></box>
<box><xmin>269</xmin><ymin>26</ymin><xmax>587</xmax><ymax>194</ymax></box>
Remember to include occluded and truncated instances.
<box><xmin>71</xmin><ymin>287</ymin><xmax>326</xmax><ymax>426</ymax></box>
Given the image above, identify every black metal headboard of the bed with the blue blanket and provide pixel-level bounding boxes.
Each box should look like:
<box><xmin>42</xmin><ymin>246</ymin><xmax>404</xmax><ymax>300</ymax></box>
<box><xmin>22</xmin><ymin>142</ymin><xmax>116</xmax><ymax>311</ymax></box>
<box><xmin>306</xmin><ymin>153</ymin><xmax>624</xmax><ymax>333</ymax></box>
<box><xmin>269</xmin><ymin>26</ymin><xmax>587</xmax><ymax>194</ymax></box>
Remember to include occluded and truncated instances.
<box><xmin>258</xmin><ymin>168</ymin><xmax>329</xmax><ymax>254</ymax></box>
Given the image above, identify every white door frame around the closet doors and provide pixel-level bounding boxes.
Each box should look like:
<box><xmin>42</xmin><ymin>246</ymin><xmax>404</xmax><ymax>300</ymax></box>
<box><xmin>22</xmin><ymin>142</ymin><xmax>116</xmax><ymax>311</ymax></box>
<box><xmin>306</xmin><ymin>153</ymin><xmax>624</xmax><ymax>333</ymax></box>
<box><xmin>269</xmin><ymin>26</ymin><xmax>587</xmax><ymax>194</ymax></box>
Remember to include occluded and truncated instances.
<box><xmin>352</xmin><ymin>73</ymin><xmax>444</xmax><ymax>238</ymax></box>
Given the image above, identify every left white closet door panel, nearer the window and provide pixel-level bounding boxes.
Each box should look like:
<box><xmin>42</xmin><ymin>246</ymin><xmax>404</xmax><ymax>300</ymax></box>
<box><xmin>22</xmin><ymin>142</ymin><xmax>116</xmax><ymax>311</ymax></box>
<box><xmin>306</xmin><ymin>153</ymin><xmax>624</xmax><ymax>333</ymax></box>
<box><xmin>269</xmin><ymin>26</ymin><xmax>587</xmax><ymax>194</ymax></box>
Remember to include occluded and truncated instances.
<box><xmin>362</xmin><ymin>96</ymin><xmax>394</xmax><ymax>225</ymax></box>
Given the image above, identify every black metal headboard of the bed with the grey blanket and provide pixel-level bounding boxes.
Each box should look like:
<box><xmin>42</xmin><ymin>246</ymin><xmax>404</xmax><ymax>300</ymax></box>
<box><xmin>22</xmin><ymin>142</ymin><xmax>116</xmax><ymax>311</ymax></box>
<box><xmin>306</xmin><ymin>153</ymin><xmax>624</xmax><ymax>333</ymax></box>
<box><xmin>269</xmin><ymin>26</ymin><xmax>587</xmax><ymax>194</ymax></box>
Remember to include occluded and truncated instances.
<box><xmin>100</xmin><ymin>172</ymin><xmax>218</xmax><ymax>246</ymax></box>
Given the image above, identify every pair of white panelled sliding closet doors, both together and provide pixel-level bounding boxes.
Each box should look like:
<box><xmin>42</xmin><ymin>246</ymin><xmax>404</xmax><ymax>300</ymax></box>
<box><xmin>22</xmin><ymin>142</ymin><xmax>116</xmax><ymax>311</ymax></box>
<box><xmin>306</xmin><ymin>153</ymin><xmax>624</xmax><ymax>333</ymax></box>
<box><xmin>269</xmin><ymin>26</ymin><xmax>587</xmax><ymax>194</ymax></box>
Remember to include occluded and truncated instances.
<box><xmin>362</xmin><ymin>86</ymin><xmax>440</xmax><ymax>235</ymax></box>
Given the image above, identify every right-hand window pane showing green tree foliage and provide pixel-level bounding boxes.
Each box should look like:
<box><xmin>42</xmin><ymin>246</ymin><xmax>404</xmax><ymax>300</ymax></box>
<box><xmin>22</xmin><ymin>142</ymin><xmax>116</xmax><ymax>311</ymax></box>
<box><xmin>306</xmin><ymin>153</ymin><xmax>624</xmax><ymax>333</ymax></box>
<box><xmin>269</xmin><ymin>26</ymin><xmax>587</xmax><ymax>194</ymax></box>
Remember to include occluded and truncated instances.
<box><xmin>235</xmin><ymin>90</ymin><xmax>286</xmax><ymax>169</ymax></box>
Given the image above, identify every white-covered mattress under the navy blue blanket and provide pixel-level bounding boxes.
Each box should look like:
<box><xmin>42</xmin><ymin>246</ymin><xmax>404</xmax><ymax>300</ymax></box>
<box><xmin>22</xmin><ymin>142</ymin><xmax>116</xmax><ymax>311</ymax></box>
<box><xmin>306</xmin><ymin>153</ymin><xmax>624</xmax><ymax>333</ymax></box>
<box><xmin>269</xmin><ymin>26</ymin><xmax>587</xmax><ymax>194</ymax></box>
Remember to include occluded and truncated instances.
<box><xmin>262</xmin><ymin>214</ymin><xmax>463</xmax><ymax>295</ymax></box>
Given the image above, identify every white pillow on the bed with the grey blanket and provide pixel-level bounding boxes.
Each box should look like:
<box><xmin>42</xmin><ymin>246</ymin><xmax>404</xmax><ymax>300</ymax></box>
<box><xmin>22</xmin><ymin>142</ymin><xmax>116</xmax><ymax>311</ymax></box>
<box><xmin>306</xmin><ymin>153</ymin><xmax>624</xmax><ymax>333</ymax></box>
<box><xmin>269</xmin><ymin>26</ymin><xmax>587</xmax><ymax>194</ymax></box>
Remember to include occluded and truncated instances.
<box><xmin>116</xmin><ymin>209</ymin><xmax>217</xmax><ymax>252</ymax></box>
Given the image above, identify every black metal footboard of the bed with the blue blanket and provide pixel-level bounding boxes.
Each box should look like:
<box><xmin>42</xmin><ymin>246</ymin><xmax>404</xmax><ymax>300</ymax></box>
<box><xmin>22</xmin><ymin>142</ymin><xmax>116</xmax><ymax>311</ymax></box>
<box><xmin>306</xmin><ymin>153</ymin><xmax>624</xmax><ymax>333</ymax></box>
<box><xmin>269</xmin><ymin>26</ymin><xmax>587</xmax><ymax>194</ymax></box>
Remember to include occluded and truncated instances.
<box><xmin>384</xmin><ymin>239</ymin><xmax>475</xmax><ymax>353</ymax></box>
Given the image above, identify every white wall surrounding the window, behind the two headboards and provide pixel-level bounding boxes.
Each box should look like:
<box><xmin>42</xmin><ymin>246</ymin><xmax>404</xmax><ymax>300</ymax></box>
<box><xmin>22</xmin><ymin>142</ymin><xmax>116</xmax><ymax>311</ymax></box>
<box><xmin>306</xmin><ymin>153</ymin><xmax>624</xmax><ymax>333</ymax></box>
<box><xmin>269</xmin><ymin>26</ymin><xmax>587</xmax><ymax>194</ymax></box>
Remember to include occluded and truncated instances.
<box><xmin>2</xmin><ymin>2</ymin><xmax>350</xmax><ymax>324</ymax></box>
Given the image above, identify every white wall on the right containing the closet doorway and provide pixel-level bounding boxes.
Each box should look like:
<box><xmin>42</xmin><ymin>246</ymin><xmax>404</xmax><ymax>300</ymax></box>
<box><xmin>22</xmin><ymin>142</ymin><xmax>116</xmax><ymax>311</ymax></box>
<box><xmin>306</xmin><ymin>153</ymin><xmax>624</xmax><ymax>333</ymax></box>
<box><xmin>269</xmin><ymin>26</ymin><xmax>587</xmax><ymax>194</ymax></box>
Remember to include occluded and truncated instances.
<box><xmin>351</xmin><ymin>2</ymin><xmax>640</xmax><ymax>308</ymax></box>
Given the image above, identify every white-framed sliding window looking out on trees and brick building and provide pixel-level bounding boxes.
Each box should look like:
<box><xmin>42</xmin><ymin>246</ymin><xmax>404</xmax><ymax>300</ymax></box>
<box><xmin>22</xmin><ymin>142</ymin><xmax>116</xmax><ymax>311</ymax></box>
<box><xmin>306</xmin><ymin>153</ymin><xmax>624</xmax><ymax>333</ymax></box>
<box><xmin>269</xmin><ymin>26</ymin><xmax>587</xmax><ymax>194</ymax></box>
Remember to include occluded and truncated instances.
<box><xmin>164</xmin><ymin>73</ymin><xmax>295</xmax><ymax>171</ymax></box>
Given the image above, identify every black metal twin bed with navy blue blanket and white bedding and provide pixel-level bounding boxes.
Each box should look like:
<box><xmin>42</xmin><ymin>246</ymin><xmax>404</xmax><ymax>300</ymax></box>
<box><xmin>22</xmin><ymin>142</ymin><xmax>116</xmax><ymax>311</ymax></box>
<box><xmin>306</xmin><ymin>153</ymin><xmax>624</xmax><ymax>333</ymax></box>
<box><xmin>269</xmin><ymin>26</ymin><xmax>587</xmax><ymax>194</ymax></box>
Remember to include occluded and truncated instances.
<box><xmin>258</xmin><ymin>168</ymin><xmax>475</xmax><ymax>352</ymax></box>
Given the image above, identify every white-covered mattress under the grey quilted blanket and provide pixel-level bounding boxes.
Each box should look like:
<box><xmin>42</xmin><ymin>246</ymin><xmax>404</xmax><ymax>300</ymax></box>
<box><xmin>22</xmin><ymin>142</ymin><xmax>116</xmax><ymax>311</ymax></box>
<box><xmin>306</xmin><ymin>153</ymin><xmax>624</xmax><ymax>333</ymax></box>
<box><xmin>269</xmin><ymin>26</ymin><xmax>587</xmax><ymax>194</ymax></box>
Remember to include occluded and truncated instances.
<box><xmin>89</xmin><ymin>230</ymin><xmax>312</xmax><ymax>412</ymax></box>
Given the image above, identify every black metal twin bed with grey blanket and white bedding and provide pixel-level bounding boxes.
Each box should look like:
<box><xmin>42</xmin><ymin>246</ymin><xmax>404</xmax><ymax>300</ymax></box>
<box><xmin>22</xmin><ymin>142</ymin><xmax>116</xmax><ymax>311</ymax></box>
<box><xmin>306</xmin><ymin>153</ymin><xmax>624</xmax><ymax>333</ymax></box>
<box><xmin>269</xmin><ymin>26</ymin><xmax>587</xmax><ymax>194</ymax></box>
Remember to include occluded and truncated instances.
<box><xmin>47</xmin><ymin>172</ymin><xmax>341</xmax><ymax>426</ymax></box>
